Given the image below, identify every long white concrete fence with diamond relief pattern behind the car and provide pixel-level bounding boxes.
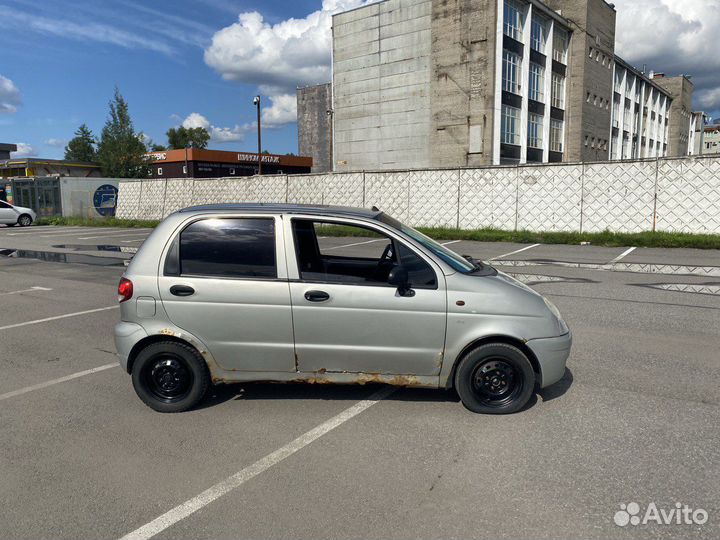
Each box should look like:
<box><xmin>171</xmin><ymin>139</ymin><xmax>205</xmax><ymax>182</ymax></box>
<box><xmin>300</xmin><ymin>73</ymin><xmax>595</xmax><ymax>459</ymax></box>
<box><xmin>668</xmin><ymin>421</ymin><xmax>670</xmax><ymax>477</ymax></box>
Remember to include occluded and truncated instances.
<box><xmin>117</xmin><ymin>156</ymin><xmax>720</xmax><ymax>234</ymax></box>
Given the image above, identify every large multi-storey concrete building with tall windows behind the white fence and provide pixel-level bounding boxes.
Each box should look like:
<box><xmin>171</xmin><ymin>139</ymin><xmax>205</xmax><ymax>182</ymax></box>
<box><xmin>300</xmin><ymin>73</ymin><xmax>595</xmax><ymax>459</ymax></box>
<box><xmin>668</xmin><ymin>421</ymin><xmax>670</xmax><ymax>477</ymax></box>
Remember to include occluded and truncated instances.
<box><xmin>298</xmin><ymin>0</ymin><xmax>692</xmax><ymax>171</ymax></box>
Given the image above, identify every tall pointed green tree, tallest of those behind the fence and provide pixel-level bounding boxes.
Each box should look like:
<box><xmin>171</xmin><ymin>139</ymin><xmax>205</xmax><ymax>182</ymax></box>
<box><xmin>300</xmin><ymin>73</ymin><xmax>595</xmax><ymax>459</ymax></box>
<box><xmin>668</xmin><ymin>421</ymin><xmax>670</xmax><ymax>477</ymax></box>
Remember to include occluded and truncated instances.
<box><xmin>97</xmin><ymin>87</ymin><xmax>149</xmax><ymax>178</ymax></box>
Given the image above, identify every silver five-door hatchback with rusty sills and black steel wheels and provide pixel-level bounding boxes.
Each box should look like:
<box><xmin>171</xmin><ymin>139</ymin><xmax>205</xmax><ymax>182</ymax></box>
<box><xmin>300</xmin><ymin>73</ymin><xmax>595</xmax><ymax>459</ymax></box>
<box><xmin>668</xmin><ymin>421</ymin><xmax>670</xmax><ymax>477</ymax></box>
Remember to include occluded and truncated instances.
<box><xmin>115</xmin><ymin>204</ymin><xmax>572</xmax><ymax>413</ymax></box>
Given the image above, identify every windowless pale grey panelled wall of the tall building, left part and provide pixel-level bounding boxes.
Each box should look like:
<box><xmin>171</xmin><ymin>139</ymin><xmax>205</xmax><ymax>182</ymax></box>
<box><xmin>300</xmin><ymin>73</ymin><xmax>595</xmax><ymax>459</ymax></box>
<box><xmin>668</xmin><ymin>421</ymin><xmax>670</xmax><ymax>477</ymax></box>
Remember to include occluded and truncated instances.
<box><xmin>333</xmin><ymin>0</ymin><xmax>432</xmax><ymax>171</ymax></box>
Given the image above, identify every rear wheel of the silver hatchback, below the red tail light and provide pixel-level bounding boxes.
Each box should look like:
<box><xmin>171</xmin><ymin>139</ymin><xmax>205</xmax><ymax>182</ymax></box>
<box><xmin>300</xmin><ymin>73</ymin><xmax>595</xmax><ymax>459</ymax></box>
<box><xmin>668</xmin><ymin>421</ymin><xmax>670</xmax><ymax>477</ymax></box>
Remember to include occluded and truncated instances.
<box><xmin>132</xmin><ymin>341</ymin><xmax>210</xmax><ymax>413</ymax></box>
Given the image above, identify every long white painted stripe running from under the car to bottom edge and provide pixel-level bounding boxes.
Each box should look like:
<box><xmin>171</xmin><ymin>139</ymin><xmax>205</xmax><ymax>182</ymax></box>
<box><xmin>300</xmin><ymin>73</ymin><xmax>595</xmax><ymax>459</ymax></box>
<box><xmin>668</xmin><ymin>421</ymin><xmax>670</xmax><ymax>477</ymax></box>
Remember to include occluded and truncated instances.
<box><xmin>121</xmin><ymin>387</ymin><xmax>396</xmax><ymax>540</ymax></box>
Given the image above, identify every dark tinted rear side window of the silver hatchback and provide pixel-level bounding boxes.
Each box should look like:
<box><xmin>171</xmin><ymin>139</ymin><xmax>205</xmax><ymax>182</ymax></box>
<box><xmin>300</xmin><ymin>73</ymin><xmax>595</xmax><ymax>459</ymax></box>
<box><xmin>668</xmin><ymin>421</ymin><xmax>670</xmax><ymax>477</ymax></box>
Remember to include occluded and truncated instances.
<box><xmin>180</xmin><ymin>218</ymin><xmax>277</xmax><ymax>278</ymax></box>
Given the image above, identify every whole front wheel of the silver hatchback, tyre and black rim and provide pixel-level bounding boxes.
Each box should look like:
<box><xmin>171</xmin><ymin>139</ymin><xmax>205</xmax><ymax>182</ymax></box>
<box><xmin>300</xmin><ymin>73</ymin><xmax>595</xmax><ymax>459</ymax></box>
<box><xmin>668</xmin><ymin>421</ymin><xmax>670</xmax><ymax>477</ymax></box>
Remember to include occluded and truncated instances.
<box><xmin>455</xmin><ymin>343</ymin><xmax>535</xmax><ymax>414</ymax></box>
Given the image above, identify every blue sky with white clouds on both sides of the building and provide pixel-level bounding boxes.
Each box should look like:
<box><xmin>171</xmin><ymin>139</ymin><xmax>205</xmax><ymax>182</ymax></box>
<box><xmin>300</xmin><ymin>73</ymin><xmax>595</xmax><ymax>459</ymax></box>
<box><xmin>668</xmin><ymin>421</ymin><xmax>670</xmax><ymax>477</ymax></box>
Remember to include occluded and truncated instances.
<box><xmin>0</xmin><ymin>0</ymin><xmax>720</xmax><ymax>158</ymax></box>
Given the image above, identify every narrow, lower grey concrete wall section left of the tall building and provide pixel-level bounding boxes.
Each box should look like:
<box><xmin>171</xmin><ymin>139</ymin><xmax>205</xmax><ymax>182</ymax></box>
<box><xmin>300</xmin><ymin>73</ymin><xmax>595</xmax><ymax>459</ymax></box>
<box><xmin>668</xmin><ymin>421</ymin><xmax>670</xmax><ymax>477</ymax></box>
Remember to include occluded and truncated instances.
<box><xmin>297</xmin><ymin>83</ymin><xmax>333</xmax><ymax>172</ymax></box>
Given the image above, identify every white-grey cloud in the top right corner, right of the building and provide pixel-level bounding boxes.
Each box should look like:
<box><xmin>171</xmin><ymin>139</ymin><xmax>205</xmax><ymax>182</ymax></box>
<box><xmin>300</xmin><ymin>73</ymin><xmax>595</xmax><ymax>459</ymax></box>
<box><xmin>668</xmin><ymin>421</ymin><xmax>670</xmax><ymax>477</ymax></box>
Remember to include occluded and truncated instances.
<box><xmin>615</xmin><ymin>0</ymin><xmax>720</xmax><ymax>111</ymax></box>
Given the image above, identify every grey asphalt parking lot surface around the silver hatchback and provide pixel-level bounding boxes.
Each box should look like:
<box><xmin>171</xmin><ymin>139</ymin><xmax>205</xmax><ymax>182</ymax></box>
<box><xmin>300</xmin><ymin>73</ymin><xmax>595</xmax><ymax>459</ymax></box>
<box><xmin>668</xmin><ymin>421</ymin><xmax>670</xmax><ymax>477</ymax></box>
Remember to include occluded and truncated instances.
<box><xmin>0</xmin><ymin>227</ymin><xmax>720</xmax><ymax>539</ymax></box>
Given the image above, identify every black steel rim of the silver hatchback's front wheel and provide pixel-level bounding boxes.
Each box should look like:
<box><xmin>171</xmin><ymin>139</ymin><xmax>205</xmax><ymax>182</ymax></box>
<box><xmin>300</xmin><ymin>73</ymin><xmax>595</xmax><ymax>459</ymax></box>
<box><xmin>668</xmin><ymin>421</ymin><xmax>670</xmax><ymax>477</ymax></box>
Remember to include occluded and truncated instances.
<box><xmin>472</xmin><ymin>358</ymin><xmax>524</xmax><ymax>407</ymax></box>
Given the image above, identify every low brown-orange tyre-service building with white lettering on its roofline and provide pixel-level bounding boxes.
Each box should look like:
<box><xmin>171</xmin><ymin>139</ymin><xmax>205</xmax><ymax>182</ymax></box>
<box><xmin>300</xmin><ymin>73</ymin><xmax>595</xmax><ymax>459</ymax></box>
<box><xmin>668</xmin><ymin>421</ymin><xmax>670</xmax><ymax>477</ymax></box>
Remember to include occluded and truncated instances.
<box><xmin>146</xmin><ymin>148</ymin><xmax>312</xmax><ymax>178</ymax></box>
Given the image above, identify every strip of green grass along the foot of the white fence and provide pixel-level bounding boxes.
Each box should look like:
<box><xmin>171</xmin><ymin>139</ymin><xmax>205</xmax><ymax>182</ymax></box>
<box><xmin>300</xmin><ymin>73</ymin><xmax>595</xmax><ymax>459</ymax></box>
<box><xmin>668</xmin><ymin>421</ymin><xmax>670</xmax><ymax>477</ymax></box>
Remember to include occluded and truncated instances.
<box><xmin>35</xmin><ymin>217</ymin><xmax>720</xmax><ymax>249</ymax></box>
